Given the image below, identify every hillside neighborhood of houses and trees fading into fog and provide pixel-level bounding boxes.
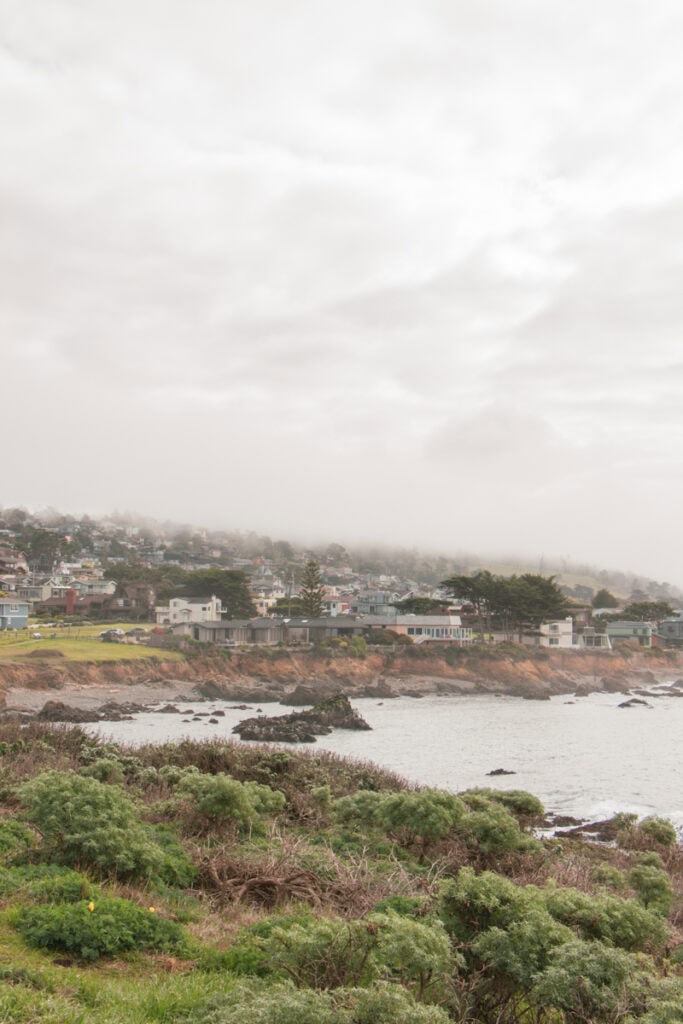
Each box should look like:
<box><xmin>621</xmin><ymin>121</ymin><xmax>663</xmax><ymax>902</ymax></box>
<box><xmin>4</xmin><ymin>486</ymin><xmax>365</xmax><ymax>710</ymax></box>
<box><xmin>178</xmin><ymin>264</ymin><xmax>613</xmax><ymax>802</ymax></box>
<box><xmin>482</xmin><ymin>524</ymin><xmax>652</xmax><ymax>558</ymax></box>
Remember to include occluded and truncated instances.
<box><xmin>0</xmin><ymin>510</ymin><xmax>683</xmax><ymax>650</ymax></box>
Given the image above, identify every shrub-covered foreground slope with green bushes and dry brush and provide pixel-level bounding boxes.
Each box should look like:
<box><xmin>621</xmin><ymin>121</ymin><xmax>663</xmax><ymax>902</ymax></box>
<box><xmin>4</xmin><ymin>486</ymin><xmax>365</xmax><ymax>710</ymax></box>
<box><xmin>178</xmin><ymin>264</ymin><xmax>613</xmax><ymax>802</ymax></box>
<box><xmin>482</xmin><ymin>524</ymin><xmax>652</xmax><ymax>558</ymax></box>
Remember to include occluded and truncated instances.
<box><xmin>0</xmin><ymin>723</ymin><xmax>683</xmax><ymax>1024</ymax></box>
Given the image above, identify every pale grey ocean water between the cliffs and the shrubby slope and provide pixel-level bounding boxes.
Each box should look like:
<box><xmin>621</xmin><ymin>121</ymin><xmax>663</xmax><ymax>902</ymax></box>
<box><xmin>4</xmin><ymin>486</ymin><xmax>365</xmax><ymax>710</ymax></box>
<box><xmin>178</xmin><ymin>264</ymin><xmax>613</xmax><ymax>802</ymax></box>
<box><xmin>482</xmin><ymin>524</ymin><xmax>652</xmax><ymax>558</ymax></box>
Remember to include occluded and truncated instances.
<box><xmin>87</xmin><ymin>693</ymin><xmax>683</xmax><ymax>830</ymax></box>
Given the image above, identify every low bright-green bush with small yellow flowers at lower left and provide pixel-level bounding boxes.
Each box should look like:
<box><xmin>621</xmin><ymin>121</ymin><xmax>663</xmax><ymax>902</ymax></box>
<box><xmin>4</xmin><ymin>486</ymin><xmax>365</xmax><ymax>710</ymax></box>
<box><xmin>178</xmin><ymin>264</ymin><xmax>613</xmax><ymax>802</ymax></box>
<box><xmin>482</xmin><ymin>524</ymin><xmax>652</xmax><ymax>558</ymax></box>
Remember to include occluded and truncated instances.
<box><xmin>12</xmin><ymin>898</ymin><xmax>187</xmax><ymax>961</ymax></box>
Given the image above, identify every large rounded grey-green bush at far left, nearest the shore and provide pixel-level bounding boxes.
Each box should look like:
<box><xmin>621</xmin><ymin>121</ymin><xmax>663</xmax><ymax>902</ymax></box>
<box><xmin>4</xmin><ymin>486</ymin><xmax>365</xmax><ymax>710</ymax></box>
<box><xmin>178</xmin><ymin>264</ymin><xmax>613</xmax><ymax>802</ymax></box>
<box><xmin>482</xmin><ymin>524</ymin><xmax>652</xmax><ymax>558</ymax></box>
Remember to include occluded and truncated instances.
<box><xmin>19</xmin><ymin>771</ymin><xmax>164</xmax><ymax>879</ymax></box>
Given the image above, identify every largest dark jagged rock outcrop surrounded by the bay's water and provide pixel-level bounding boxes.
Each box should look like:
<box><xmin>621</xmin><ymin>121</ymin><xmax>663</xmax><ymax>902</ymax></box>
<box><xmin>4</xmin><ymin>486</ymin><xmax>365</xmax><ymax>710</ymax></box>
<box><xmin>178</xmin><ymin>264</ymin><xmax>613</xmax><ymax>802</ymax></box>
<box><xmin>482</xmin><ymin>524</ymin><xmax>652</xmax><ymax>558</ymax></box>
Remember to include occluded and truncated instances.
<box><xmin>232</xmin><ymin>693</ymin><xmax>371</xmax><ymax>743</ymax></box>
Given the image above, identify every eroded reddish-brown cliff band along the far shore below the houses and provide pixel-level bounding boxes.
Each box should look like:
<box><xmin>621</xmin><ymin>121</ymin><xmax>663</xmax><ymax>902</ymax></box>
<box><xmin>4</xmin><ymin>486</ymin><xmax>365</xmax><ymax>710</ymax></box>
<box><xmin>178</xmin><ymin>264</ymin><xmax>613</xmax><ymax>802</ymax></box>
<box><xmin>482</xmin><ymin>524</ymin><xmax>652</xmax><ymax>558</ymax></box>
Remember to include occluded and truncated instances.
<box><xmin>0</xmin><ymin>648</ymin><xmax>683</xmax><ymax>699</ymax></box>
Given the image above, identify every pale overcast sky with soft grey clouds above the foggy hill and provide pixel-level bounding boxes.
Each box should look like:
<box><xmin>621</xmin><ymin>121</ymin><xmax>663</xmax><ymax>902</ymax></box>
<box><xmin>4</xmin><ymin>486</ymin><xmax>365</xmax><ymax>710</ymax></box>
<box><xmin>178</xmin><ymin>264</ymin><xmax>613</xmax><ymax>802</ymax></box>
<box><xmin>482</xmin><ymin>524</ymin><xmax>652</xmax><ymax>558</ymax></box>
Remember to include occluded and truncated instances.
<box><xmin>0</xmin><ymin>0</ymin><xmax>683</xmax><ymax>585</ymax></box>
